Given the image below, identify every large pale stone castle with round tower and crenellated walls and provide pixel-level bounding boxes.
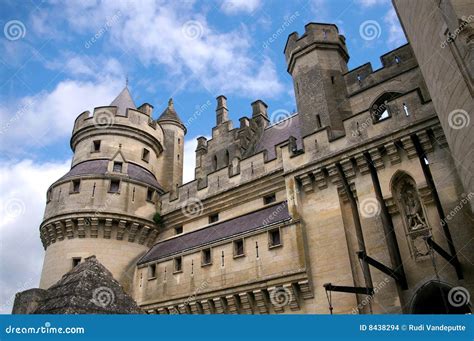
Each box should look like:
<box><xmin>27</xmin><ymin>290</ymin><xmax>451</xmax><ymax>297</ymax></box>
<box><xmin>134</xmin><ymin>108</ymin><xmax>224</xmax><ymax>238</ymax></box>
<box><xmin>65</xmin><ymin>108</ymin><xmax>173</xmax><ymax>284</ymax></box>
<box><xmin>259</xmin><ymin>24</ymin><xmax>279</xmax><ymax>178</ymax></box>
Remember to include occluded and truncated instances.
<box><xmin>25</xmin><ymin>15</ymin><xmax>474</xmax><ymax>314</ymax></box>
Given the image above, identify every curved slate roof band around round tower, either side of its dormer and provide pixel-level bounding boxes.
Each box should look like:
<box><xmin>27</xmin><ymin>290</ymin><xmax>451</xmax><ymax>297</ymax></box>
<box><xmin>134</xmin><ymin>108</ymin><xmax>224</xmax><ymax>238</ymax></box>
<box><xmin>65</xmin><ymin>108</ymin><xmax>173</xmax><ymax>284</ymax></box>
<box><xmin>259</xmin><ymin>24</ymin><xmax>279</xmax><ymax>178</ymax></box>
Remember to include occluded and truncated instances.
<box><xmin>58</xmin><ymin>160</ymin><xmax>163</xmax><ymax>188</ymax></box>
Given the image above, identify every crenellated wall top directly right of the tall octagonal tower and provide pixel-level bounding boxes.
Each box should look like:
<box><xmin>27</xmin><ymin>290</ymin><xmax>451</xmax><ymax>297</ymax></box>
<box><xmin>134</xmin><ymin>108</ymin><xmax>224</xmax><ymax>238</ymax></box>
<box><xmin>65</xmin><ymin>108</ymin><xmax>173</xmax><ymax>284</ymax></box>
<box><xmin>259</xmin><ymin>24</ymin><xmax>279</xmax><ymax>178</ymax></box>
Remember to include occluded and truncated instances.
<box><xmin>343</xmin><ymin>44</ymin><xmax>418</xmax><ymax>96</ymax></box>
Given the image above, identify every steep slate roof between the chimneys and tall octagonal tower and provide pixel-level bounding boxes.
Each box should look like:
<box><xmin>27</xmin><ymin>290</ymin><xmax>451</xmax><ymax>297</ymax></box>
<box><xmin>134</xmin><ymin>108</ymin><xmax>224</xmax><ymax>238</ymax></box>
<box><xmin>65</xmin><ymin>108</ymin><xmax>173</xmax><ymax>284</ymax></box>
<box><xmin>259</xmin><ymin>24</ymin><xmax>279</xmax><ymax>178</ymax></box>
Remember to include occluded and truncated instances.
<box><xmin>255</xmin><ymin>114</ymin><xmax>303</xmax><ymax>160</ymax></box>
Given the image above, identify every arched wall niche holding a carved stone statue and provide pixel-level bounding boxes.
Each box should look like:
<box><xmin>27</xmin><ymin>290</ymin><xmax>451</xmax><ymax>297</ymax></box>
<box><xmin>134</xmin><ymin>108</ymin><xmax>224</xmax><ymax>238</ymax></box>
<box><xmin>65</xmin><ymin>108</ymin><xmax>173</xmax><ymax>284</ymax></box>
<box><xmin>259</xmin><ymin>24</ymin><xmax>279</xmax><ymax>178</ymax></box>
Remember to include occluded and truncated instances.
<box><xmin>392</xmin><ymin>172</ymin><xmax>431</xmax><ymax>259</ymax></box>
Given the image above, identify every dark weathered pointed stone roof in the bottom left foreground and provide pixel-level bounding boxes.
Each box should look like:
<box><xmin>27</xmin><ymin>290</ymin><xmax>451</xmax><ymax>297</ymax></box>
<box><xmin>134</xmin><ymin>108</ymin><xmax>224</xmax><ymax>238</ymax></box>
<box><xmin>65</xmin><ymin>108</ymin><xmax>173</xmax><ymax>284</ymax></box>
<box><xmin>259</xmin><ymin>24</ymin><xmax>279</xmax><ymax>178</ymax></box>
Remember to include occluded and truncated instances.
<box><xmin>13</xmin><ymin>256</ymin><xmax>143</xmax><ymax>314</ymax></box>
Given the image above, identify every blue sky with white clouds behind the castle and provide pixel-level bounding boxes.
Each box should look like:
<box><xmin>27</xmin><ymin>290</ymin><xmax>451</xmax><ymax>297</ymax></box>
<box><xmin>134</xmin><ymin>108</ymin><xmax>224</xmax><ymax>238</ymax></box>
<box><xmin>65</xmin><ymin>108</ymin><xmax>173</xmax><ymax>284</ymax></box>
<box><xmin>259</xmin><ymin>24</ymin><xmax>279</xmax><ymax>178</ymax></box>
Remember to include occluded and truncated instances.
<box><xmin>0</xmin><ymin>0</ymin><xmax>406</xmax><ymax>312</ymax></box>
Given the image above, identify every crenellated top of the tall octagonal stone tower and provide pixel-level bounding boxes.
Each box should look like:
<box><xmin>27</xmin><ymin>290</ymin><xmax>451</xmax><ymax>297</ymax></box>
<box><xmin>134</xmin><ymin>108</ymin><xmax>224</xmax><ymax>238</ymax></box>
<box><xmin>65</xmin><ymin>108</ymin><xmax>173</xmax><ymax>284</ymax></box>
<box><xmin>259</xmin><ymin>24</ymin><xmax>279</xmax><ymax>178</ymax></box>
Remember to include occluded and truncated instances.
<box><xmin>284</xmin><ymin>23</ymin><xmax>349</xmax><ymax>73</ymax></box>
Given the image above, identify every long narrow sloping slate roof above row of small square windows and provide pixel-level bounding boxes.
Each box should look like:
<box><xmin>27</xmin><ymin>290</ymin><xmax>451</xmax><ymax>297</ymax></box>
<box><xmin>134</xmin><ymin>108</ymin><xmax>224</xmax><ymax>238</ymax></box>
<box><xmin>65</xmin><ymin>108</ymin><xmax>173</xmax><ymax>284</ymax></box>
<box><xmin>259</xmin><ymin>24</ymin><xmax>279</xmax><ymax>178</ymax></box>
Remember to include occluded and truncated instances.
<box><xmin>138</xmin><ymin>201</ymin><xmax>290</xmax><ymax>264</ymax></box>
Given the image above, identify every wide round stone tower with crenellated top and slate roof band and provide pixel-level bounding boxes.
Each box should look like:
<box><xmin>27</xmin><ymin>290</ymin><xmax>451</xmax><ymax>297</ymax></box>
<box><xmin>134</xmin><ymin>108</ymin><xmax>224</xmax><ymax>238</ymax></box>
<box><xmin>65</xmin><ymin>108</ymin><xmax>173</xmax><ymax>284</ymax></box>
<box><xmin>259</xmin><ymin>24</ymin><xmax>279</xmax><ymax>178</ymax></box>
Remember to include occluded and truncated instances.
<box><xmin>40</xmin><ymin>87</ymin><xmax>170</xmax><ymax>291</ymax></box>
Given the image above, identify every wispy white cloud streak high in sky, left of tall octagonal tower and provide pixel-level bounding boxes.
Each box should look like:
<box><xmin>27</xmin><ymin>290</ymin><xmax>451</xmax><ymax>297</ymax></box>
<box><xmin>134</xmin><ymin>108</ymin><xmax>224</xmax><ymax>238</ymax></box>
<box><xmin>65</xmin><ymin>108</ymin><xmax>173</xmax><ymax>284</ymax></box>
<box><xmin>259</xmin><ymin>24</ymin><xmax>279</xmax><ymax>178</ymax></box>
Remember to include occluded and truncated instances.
<box><xmin>40</xmin><ymin>1</ymin><xmax>284</xmax><ymax>97</ymax></box>
